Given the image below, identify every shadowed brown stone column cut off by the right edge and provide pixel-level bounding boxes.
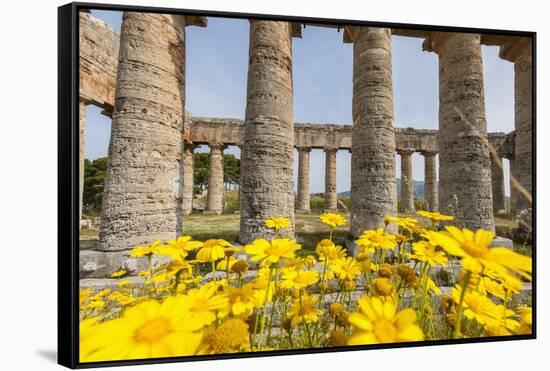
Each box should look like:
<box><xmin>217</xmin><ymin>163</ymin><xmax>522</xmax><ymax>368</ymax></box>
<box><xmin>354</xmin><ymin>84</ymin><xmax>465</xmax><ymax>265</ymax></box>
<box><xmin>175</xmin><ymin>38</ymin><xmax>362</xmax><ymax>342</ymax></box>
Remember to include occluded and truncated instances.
<box><xmin>500</xmin><ymin>37</ymin><xmax>533</xmax><ymax>211</ymax></box>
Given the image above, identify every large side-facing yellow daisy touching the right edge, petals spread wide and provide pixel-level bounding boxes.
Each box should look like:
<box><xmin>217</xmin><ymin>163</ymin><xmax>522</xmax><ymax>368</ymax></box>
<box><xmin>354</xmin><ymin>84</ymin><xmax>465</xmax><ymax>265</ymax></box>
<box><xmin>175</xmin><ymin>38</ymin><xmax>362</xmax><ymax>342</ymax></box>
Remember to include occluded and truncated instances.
<box><xmin>426</xmin><ymin>227</ymin><xmax>533</xmax><ymax>279</ymax></box>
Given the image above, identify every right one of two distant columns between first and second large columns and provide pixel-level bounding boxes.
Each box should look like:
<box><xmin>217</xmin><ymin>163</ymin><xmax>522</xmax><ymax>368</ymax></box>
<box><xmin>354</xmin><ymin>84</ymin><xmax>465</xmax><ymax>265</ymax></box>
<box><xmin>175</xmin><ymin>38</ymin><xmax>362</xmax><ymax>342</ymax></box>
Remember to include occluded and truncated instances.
<box><xmin>206</xmin><ymin>143</ymin><xmax>224</xmax><ymax>215</ymax></box>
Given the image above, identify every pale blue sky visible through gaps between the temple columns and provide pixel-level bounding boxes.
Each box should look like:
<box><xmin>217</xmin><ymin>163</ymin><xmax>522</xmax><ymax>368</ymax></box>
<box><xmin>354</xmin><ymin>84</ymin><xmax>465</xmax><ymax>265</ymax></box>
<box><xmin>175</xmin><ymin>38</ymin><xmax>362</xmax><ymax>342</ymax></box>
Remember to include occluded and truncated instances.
<box><xmin>85</xmin><ymin>11</ymin><xmax>514</xmax><ymax>194</ymax></box>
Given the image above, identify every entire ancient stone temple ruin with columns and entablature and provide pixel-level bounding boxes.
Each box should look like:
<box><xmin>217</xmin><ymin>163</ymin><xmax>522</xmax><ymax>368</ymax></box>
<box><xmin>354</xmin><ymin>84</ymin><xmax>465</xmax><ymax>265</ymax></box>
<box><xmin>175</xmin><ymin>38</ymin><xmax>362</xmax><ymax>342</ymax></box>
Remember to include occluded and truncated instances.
<box><xmin>80</xmin><ymin>12</ymin><xmax>533</xmax><ymax>277</ymax></box>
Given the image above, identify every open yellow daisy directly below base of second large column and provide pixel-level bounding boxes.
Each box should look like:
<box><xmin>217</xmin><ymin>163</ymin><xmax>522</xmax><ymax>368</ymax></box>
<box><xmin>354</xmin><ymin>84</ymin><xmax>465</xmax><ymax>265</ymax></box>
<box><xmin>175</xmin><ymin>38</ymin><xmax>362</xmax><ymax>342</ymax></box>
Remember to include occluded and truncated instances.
<box><xmin>245</xmin><ymin>238</ymin><xmax>300</xmax><ymax>266</ymax></box>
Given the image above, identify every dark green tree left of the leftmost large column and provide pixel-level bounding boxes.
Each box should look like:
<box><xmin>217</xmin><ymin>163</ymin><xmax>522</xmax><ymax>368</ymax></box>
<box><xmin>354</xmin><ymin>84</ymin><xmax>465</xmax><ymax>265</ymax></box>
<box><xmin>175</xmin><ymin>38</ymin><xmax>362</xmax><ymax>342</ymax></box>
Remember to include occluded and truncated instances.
<box><xmin>83</xmin><ymin>157</ymin><xmax>107</xmax><ymax>213</ymax></box>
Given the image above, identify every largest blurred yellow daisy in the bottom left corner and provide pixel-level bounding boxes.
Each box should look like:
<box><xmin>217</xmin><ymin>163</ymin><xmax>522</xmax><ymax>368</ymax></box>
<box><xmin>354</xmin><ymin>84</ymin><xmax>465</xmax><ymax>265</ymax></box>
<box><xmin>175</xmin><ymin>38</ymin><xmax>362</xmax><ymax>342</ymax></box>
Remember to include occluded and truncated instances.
<box><xmin>80</xmin><ymin>297</ymin><xmax>202</xmax><ymax>362</ymax></box>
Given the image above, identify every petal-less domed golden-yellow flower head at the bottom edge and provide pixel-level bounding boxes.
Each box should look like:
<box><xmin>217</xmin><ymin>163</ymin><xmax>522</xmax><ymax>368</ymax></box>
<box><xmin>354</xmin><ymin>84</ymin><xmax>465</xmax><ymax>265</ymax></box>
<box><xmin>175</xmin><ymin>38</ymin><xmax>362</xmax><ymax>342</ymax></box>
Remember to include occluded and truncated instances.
<box><xmin>197</xmin><ymin>319</ymin><xmax>250</xmax><ymax>354</ymax></box>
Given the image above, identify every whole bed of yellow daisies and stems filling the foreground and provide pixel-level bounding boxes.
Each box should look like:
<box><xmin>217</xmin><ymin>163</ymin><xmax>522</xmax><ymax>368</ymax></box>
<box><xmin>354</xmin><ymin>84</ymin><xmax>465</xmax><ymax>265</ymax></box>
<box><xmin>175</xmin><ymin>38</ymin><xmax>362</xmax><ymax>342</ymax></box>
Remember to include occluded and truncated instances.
<box><xmin>80</xmin><ymin>212</ymin><xmax>532</xmax><ymax>362</ymax></box>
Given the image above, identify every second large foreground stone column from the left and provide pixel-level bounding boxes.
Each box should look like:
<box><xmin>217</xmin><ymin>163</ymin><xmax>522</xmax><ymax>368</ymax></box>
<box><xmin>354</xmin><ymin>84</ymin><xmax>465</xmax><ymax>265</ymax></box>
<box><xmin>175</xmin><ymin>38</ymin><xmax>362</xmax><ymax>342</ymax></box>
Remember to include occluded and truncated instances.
<box><xmin>240</xmin><ymin>20</ymin><xmax>294</xmax><ymax>243</ymax></box>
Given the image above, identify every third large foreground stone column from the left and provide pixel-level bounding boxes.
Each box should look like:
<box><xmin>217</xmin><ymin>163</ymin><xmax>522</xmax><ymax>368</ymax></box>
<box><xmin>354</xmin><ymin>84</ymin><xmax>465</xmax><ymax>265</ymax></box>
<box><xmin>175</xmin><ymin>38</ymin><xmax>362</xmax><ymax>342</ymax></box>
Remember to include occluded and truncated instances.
<box><xmin>351</xmin><ymin>27</ymin><xmax>397</xmax><ymax>236</ymax></box>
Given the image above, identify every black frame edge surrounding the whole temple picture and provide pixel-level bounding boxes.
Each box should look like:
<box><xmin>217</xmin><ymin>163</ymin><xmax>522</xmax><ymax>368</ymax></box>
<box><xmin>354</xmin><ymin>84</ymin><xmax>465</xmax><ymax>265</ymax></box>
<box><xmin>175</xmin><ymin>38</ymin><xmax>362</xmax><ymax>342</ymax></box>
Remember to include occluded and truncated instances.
<box><xmin>57</xmin><ymin>2</ymin><xmax>537</xmax><ymax>368</ymax></box>
